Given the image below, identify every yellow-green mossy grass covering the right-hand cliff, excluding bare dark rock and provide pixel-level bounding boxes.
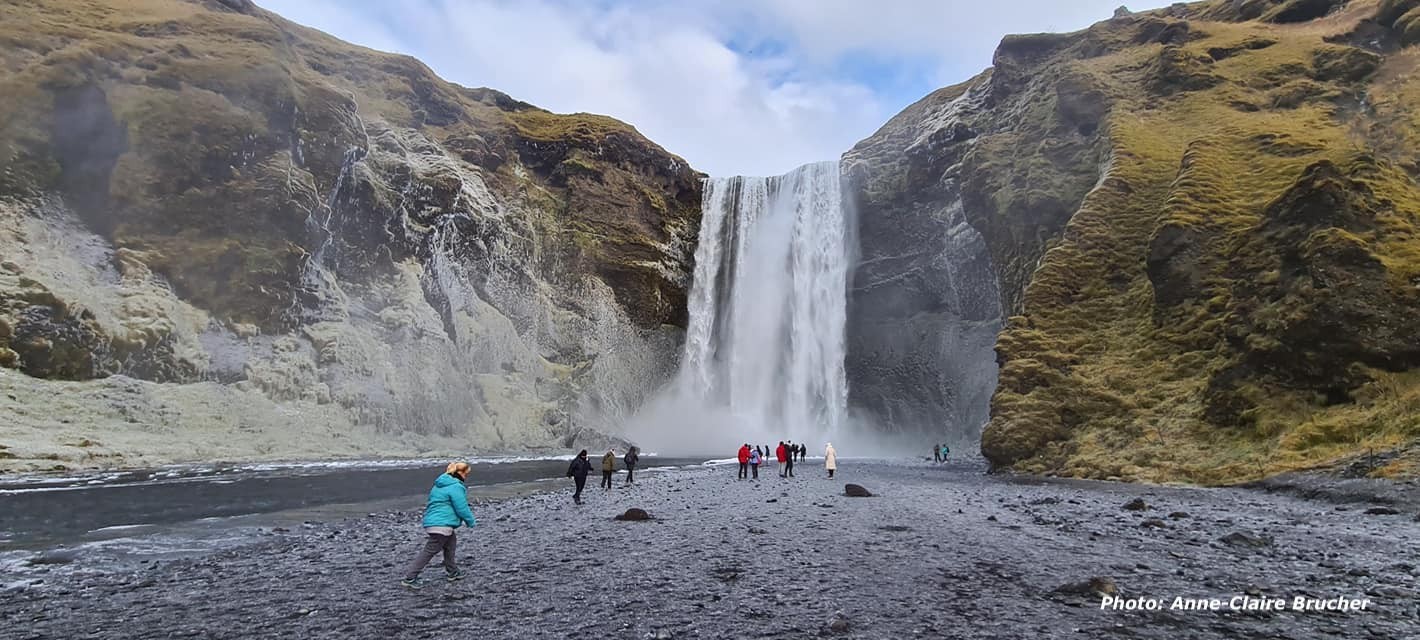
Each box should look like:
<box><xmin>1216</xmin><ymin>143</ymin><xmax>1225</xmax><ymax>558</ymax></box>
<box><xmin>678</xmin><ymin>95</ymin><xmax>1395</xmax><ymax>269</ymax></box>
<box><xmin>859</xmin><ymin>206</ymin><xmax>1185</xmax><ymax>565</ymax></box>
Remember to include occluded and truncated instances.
<box><xmin>994</xmin><ymin>6</ymin><xmax>1420</xmax><ymax>484</ymax></box>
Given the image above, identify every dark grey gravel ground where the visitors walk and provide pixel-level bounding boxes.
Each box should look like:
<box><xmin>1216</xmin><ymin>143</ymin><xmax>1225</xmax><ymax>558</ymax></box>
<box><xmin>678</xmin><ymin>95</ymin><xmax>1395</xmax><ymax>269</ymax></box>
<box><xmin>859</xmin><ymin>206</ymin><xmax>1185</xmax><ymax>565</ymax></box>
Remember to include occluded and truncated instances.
<box><xmin>0</xmin><ymin>460</ymin><xmax>1420</xmax><ymax>639</ymax></box>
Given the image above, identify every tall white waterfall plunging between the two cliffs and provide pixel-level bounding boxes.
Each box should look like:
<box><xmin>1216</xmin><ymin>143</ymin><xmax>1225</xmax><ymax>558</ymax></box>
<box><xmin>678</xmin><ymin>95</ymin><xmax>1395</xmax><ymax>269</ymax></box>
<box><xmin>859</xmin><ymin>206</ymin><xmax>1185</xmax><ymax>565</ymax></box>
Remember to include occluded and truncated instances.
<box><xmin>657</xmin><ymin>162</ymin><xmax>851</xmax><ymax>447</ymax></box>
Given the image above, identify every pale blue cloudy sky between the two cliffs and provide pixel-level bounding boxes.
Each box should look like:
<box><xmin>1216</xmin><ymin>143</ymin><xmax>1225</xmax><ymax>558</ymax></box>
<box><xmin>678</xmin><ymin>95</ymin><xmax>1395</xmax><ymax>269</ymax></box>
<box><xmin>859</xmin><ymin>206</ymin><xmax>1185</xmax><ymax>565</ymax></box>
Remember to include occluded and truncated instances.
<box><xmin>257</xmin><ymin>0</ymin><xmax>1169</xmax><ymax>176</ymax></box>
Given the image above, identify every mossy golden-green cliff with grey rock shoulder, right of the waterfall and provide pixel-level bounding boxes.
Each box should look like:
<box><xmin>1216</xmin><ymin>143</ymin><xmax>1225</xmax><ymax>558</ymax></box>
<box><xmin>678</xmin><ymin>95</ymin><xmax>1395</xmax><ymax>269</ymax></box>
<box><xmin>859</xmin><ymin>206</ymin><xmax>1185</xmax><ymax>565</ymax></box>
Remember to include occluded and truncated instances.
<box><xmin>845</xmin><ymin>0</ymin><xmax>1420</xmax><ymax>484</ymax></box>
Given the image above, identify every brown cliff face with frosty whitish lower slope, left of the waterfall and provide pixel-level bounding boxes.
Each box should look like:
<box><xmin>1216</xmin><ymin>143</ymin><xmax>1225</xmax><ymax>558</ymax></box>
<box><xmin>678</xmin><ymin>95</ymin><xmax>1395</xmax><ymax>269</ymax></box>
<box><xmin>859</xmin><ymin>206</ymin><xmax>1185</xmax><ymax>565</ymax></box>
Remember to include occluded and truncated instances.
<box><xmin>0</xmin><ymin>0</ymin><xmax>700</xmax><ymax>467</ymax></box>
